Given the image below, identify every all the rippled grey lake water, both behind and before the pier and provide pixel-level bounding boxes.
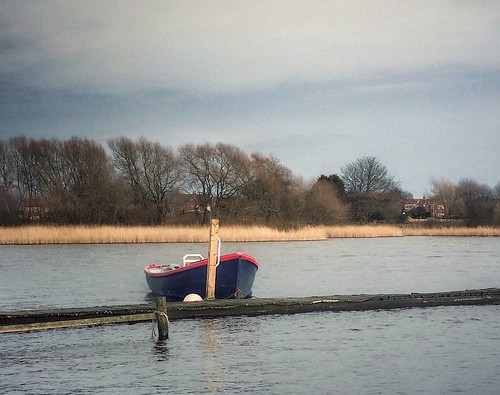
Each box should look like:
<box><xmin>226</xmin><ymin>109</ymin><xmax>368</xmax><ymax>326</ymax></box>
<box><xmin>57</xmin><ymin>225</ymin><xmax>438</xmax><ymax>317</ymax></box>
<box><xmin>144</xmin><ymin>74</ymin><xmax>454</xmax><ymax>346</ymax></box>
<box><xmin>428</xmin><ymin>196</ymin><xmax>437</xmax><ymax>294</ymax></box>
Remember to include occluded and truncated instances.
<box><xmin>0</xmin><ymin>237</ymin><xmax>500</xmax><ymax>394</ymax></box>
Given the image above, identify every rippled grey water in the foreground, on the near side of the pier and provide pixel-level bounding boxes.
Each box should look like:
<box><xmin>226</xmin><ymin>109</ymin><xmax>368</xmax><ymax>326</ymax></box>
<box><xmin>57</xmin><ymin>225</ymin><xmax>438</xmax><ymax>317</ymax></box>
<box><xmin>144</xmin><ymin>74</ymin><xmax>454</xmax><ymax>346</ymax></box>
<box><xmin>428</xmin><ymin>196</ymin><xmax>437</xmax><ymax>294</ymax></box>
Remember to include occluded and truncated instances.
<box><xmin>0</xmin><ymin>306</ymin><xmax>500</xmax><ymax>395</ymax></box>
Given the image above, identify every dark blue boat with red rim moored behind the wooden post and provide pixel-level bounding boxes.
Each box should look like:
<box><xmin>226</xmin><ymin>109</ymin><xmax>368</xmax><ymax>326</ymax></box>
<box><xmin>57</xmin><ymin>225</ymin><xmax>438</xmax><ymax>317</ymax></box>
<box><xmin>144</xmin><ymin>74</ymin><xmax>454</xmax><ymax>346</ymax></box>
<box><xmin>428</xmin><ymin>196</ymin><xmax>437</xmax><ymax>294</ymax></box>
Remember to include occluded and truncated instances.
<box><xmin>144</xmin><ymin>252</ymin><xmax>259</xmax><ymax>301</ymax></box>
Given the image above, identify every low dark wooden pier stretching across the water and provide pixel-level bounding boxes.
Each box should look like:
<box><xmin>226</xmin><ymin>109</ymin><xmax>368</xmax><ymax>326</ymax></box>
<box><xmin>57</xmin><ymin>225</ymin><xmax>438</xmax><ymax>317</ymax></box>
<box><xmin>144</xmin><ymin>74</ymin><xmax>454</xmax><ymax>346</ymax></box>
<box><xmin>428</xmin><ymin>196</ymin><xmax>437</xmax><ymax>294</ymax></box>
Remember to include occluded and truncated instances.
<box><xmin>0</xmin><ymin>288</ymin><xmax>500</xmax><ymax>335</ymax></box>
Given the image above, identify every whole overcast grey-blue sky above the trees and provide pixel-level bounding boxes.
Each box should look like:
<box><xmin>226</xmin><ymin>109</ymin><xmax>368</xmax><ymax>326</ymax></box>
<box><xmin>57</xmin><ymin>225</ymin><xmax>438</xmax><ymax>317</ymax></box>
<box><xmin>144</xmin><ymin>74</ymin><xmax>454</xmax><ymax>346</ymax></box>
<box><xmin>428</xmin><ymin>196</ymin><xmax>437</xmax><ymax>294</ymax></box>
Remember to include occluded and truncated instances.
<box><xmin>0</xmin><ymin>0</ymin><xmax>500</xmax><ymax>197</ymax></box>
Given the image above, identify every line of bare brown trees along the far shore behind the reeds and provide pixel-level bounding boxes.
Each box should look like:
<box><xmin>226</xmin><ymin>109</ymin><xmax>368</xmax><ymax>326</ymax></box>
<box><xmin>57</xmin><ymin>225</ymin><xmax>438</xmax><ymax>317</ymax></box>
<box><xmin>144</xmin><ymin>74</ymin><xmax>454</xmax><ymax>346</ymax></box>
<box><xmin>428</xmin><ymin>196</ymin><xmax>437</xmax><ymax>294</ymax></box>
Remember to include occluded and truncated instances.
<box><xmin>0</xmin><ymin>136</ymin><xmax>500</xmax><ymax>228</ymax></box>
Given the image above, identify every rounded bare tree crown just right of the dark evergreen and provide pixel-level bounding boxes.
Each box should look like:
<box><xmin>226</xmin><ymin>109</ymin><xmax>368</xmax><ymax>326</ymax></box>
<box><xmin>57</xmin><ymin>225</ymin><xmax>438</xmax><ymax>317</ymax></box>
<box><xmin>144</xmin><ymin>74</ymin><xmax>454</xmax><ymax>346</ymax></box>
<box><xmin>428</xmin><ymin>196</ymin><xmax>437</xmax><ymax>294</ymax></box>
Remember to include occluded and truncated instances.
<box><xmin>341</xmin><ymin>156</ymin><xmax>399</xmax><ymax>193</ymax></box>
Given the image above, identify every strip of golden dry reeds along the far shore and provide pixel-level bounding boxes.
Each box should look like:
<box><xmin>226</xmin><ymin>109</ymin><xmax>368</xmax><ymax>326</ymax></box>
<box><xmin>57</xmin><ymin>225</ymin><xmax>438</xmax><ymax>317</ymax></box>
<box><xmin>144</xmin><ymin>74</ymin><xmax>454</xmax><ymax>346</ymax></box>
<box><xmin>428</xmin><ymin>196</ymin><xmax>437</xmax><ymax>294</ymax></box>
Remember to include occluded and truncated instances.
<box><xmin>0</xmin><ymin>225</ymin><xmax>500</xmax><ymax>245</ymax></box>
